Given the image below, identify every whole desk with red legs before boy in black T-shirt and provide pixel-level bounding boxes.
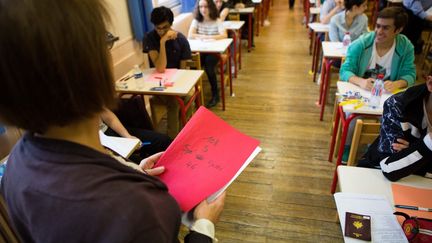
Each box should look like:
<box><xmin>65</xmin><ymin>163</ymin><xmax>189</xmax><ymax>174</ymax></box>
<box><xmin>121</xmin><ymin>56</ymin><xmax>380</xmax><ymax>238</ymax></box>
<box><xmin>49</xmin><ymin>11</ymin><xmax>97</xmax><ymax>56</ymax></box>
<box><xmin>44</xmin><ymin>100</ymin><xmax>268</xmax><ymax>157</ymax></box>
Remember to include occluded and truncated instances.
<box><xmin>115</xmin><ymin>68</ymin><xmax>204</xmax><ymax>126</ymax></box>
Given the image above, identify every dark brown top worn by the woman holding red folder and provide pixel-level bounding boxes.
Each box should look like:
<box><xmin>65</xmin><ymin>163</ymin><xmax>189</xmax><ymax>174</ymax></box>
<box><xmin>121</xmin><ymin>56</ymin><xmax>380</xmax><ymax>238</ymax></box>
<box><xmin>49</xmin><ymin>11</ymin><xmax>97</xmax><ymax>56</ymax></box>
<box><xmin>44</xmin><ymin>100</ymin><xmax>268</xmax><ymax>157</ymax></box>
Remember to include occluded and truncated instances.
<box><xmin>1</xmin><ymin>134</ymin><xmax>211</xmax><ymax>243</ymax></box>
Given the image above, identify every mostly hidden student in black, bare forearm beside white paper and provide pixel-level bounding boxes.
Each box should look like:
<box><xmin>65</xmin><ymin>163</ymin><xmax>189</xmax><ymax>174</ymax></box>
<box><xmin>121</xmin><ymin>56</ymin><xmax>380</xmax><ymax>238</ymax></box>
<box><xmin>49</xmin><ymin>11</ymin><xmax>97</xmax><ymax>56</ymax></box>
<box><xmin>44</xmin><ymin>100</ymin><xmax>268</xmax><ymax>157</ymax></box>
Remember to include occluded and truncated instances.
<box><xmin>100</xmin><ymin>109</ymin><xmax>171</xmax><ymax>164</ymax></box>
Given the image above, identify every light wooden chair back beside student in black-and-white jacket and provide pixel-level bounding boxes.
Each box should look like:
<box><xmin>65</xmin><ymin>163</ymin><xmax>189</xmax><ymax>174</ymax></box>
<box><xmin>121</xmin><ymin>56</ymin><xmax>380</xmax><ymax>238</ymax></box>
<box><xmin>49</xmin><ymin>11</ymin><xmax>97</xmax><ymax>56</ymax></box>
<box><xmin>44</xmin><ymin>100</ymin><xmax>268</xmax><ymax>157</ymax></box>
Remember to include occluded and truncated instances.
<box><xmin>347</xmin><ymin>119</ymin><xmax>381</xmax><ymax>166</ymax></box>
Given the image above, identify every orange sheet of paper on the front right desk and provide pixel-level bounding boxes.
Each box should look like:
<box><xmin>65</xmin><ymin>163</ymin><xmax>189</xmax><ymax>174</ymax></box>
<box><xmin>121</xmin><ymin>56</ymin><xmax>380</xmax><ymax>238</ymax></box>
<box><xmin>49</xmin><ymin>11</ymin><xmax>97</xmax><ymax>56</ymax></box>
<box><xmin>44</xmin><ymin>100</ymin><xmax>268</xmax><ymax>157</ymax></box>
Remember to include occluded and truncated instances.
<box><xmin>392</xmin><ymin>183</ymin><xmax>432</xmax><ymax>222</ymax></box>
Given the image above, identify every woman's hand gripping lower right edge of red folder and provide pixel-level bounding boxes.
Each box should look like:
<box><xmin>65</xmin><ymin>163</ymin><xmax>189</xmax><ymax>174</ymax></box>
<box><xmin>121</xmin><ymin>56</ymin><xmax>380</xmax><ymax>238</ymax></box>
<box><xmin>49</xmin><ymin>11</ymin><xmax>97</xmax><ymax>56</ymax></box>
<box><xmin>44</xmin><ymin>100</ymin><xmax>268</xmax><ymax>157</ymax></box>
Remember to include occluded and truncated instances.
<box><xmin>194</xmin><ymin>192</ymin><xmax>225</xmax><ymax>224</ymax></box>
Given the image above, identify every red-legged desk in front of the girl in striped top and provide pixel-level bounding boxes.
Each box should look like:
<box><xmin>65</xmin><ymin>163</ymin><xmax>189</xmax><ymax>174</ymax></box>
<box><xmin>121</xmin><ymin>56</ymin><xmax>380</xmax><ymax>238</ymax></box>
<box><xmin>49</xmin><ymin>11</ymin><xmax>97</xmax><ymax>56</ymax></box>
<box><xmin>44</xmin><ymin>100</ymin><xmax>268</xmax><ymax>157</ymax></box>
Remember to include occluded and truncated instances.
<box><xmin>188</xmin><ymin>38</ymin><xmax>234</xmax><ymax>110</ymax></box>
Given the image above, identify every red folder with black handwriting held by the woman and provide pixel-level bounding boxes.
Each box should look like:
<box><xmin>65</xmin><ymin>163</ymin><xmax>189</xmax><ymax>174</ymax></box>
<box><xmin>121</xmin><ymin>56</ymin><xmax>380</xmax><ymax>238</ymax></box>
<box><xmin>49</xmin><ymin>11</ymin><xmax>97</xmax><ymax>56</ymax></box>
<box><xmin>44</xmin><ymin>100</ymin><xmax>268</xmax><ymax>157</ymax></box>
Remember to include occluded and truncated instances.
<box><xmin>156</xmin><ymin>106</ymin><xmax>261</xmax><ymax>212</ymax></box>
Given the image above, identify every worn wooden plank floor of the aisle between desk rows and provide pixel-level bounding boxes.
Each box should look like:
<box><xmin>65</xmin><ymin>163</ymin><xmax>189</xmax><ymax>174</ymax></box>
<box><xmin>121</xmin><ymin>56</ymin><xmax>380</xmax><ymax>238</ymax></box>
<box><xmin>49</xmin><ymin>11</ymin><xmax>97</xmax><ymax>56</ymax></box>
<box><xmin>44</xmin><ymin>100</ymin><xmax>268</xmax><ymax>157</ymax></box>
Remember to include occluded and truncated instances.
<box><xmin>188</xmin><ymin>0</ymin><xmax>342</xmax><ymax>243</ymax></box>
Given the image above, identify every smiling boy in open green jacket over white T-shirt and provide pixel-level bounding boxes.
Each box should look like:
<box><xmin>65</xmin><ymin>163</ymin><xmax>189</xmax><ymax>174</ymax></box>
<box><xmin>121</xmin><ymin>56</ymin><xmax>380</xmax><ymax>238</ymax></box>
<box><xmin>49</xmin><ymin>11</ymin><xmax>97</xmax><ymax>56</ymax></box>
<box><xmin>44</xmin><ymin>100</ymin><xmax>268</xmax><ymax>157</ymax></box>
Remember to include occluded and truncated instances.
<box><xmin>339</xmin><ymin>7</ymin><xmax>416</xmax><ymax>92</ymax></box>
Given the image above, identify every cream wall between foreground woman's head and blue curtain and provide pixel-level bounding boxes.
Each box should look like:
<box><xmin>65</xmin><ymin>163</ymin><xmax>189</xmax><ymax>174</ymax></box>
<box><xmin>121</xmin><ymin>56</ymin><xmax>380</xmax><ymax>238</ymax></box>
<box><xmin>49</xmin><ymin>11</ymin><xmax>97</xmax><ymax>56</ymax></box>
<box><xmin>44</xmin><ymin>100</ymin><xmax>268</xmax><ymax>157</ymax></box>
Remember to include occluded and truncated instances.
<box><xmin>105</xmin><ymin>0</ymin><xmax>149</xmax><ymax>79</ymax></box>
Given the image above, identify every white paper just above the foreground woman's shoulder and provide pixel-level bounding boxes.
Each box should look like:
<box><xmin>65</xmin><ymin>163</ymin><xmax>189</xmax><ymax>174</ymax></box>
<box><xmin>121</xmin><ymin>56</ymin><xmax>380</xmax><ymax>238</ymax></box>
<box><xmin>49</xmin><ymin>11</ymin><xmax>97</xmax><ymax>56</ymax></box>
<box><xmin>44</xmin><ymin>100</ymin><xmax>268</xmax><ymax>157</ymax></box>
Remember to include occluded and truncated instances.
<box><xmin>99</xmin><ymin>131</ymin><xmax>140</xmax><ymax>158</ymax></box>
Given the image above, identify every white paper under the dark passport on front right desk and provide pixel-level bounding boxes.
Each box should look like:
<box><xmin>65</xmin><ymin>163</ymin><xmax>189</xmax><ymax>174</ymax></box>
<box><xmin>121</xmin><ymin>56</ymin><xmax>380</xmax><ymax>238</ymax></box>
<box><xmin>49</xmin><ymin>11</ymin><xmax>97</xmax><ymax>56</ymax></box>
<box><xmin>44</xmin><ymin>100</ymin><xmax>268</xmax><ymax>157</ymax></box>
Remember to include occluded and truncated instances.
<box><xmin>334</xmin><ymin>192</ymin><xmax>408</xmax><ymax>243</ymax></box>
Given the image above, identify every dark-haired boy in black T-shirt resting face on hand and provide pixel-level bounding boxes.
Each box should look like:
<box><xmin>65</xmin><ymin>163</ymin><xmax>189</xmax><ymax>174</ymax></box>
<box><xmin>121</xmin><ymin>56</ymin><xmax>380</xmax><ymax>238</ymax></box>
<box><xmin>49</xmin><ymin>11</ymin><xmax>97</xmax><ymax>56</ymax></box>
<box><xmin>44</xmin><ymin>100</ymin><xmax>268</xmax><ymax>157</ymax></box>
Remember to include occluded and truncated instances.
<box><xmin>143</xmin><ymin>6</ymin><xmax>191</xmax><ymax>138</ymax></box>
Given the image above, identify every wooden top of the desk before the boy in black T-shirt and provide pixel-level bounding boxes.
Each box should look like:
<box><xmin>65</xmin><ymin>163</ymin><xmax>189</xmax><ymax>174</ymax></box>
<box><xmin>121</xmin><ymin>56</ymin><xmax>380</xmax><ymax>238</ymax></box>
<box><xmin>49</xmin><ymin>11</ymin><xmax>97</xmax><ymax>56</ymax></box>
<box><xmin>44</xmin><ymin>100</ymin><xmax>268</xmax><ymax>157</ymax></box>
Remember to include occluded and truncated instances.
<box><xmin>116</xmin><ymin>68</ymin><xmax>204</xmax><ymax>96</ymax></box>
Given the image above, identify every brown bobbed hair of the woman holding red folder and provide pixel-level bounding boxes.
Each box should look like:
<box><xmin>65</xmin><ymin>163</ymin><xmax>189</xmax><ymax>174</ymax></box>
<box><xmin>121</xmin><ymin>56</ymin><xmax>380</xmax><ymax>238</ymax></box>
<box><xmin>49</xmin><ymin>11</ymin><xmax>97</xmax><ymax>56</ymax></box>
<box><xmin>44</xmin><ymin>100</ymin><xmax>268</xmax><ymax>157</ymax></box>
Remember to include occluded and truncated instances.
<box><xmin>0</xmin><ymin>0</ymin><xmax>114</xmax><ymax>133</ymax></box>
